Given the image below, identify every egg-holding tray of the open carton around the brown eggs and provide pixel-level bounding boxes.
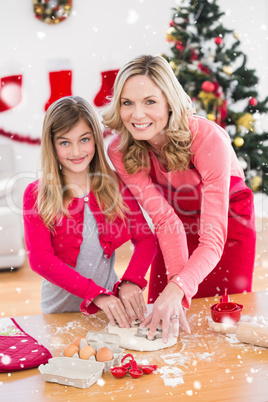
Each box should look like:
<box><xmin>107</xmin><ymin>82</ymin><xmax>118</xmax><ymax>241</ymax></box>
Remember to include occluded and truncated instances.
<box><xmin>86</xmin><ymin>331</ymin><xmax>124</xmax><ymax>372</ymax></box>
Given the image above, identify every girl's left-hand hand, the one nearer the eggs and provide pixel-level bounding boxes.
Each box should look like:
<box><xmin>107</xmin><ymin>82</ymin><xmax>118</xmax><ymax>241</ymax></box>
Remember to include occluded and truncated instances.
<box><xmin>93</xmin><ymin>294</ymin><xmax>131</xmax><ymax>328</ymax></box>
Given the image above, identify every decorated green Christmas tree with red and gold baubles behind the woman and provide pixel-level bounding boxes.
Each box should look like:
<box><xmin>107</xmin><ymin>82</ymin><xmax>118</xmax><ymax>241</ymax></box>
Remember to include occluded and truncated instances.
<box><xmin>163</xmin><ymin>0</ymin><xmax>268</xmax><ymax>193</ymax></box>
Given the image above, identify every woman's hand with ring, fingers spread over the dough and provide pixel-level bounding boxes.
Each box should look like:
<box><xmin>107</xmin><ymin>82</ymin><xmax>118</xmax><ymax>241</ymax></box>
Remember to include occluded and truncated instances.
<box><xmin>141</xmin><ymin>282</ymin><xmax>191</xmax><ymax>343</ymax></box>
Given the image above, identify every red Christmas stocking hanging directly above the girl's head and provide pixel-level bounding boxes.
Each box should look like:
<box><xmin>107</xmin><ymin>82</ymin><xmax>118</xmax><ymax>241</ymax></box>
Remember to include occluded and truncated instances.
<box><xmin>45</xmin><ymin>70</ymin><xmax>72</xmax><ymax>111</ymax></box>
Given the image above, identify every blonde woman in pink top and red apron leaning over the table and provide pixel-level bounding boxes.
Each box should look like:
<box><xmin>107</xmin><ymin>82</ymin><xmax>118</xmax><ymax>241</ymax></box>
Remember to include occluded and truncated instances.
<box><xmin>103</xmin><ymin>55</ymin><xmax>256</xmax><ymax>340</ymax></box>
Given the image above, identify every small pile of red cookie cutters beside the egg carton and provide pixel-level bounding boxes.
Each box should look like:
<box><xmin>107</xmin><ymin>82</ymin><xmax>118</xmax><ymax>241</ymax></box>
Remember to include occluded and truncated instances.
<box><xmin>110</xmin><ymin>353</ymin><xmax>157</xmax><ymax>378</ymax></box>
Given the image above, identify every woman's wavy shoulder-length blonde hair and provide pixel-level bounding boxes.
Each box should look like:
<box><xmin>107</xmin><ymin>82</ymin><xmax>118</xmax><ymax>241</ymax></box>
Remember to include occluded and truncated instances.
<box><xmin>103</xmin><ymin>55</ymin><xmax>194</xmax><ymax>174</ymax></box>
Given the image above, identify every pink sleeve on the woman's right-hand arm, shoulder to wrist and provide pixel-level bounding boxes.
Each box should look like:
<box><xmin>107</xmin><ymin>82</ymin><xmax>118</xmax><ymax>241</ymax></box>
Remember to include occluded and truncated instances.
<box><xmin>172</xmin><ymin>118</ymin><xmax>232</xmax><ymax>306</ymax></box>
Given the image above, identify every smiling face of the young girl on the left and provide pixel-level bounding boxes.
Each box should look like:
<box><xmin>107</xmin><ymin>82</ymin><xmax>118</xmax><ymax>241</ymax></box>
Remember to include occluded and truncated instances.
<box><xmin>54</xmin><ymin>120</ymin><xmax>95</xmax><ymax>176</ymax></box>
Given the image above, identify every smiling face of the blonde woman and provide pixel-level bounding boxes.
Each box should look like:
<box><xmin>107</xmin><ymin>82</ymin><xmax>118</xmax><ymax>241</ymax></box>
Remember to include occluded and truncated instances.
<box><xmin>120</xmin><ymin>75</ymin><xmax>169</xmax><ymax>148</ymax></box>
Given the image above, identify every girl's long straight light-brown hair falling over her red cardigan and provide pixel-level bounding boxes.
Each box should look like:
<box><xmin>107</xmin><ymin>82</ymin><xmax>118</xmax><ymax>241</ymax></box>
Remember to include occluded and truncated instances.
<box><xmin>37</xmin><ymin>96</ymin><xmax>127</xmax><ymax>229</ymax></box>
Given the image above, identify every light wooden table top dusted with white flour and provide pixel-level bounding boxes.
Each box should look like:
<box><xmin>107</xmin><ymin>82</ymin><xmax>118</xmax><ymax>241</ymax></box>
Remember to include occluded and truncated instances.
<box><xmin>0</xmin><ymin>292</ymin><xmax>268</xmax><ymax>402</ymax></box>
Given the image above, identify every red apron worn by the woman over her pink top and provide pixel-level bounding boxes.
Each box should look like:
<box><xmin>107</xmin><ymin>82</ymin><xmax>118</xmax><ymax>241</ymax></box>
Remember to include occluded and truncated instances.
<box><xmin>148</xmin><ymin>162</ymin><xmax>256</xmax><ymax>303</ymax></box>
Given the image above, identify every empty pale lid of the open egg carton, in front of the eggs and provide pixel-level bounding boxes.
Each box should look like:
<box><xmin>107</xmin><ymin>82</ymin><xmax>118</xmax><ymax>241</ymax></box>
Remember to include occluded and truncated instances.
<box><xmin>38</xmin><ymin>357</ymin><xmax>104</xmax><ymax>388</ymax></box>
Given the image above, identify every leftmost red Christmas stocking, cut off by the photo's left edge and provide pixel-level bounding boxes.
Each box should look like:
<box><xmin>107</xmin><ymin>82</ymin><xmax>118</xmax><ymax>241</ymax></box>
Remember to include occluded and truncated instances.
<box><xmin>0</xmin><ymin>75</ymin><xmax>22</xmax><ymax>112</ymax></box>
